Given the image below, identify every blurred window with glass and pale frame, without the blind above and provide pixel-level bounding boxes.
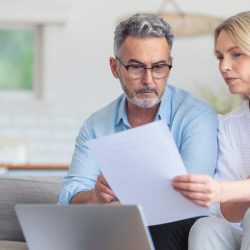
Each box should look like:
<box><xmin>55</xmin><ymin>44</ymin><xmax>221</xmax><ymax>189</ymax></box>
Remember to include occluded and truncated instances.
<box><xmin>0</xmin><ymin>26</ymin><xmax>42</xmax><ymax>100</ymax></box>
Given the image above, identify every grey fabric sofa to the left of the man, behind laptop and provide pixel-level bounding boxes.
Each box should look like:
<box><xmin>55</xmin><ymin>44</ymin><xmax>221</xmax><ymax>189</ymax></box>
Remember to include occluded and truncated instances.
<box><xmin>0</xmin><ymin>175</ymin><xmax>62</xmax><ymax>250</ymax></box>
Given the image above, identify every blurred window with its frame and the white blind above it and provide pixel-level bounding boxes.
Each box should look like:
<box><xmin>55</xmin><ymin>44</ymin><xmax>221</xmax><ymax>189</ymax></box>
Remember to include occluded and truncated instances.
<box><xmin>0</xmin><ymin>0</ymin><xmax>69</xmax><ymax>103</ymax></box>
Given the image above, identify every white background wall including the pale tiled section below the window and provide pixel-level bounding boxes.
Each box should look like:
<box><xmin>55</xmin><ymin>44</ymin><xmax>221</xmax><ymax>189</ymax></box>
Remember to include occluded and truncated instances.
<box><xmin>0</xmin><ymin>0</ymin><xmax>250</xmax><ymax>166</ymax></box>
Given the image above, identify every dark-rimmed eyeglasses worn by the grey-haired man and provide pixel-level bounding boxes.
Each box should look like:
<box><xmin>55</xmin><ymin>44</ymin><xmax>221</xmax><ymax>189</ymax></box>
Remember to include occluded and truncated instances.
<box><xmin>116</xmin><ymin>57</ymin><xmax>172</xmax><ymax>79</ymax></box>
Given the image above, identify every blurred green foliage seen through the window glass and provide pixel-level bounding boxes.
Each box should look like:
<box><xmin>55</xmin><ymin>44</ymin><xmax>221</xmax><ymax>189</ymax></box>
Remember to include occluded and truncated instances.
<box><xmin>0</xmin><ymin>29</ymin><xmax>35</xmax><ymax>91</ymax></box>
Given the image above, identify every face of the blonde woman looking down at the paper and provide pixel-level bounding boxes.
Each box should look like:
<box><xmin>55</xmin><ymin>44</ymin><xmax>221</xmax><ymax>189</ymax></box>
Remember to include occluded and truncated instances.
<box><xmin>215</xmin><ymin>30</ymin><xmax>250</xmax><ymax>97</ymax></box>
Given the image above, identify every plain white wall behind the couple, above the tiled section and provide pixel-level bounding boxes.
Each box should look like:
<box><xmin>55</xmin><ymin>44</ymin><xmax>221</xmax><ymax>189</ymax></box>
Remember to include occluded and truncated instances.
<box><xmin>45</xmin><ymin>0</ymin><xmax>250</xmax><ymax>118</ymax></box>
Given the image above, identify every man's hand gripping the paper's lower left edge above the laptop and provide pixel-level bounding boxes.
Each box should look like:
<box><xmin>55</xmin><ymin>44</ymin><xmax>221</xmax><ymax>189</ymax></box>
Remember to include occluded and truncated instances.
<box><xmin>93</xmin><ymin>174</ymin><xmax>117</xmax><ymax>204</ymax></box>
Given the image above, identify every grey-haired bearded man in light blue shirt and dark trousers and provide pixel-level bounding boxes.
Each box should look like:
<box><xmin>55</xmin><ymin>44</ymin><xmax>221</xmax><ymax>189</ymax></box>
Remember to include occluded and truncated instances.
<box><xmin>59</xmin><ymin>14</ymin><xmax>217</xmax><ymax>250</ymax></box>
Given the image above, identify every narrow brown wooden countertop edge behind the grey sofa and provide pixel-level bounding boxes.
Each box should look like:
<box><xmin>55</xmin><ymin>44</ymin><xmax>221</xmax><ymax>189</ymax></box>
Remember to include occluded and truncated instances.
<box><xmin>0</xmin><ymin>164</ymin><xmax>69</xmax><ymax>170</ymax></box>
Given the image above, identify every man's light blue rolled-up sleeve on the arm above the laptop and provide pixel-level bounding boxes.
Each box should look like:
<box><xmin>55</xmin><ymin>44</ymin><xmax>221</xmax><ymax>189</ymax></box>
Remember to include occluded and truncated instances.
<box><xmin>58</xmin><ymin>121</ymin><xmax>100</xmax><ymax>204</ymax></box>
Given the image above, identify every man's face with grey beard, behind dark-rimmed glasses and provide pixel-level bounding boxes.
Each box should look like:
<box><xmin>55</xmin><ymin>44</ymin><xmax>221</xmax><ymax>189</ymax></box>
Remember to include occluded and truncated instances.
<box><xmin>110</xmin><ymin>36</ymin><xmax>171</xmax><ymax>108</ymax></box>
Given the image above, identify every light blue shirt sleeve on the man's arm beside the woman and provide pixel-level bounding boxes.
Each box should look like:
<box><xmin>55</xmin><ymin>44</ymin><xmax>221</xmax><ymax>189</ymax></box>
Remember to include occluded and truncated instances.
<box><xmin>180</xmin><ymin>108</ymin><xmax>218</xmax><ymax>175</ymax></box>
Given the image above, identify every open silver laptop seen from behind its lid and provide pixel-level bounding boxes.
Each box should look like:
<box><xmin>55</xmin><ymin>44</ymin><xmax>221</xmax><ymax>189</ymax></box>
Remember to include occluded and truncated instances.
<box><xmin>15</xmin><ymin>204</ymin><xmax>154</xmax><ymax>250</ymax></box>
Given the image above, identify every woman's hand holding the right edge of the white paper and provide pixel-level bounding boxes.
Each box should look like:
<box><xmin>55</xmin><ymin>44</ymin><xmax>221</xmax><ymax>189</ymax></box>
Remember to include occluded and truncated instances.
<box><xmin>172</xmin><ymin>174</ymin><xmax>221</xmax><ymax>207</ymax></box>
